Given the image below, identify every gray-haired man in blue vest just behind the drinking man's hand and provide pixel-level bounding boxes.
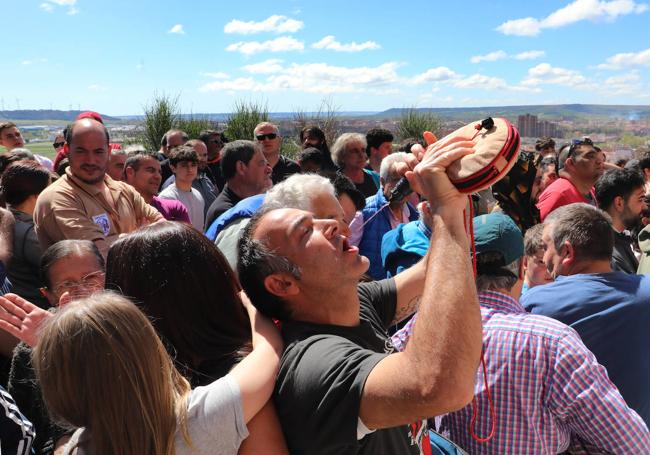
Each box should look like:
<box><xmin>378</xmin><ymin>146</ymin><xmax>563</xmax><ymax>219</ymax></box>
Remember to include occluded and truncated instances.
<box><xmin>350</xmin><ymin>152</ymin><xmax>418</xmax><ymax>280</ymax></box>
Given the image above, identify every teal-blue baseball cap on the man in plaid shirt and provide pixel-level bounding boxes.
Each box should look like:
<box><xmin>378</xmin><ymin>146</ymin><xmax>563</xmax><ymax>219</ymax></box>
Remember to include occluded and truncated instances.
<box><xmin>474</xmin><ymin>212</ymin><xmax>524</xmax><ymax>266</ymax></box>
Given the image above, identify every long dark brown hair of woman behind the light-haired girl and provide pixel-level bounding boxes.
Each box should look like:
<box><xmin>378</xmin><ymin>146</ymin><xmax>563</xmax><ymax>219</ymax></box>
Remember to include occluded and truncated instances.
<box><xmin>106</xmin><ymin>222</ymin><xmax>251</xmax><ymax>386</ymax></box>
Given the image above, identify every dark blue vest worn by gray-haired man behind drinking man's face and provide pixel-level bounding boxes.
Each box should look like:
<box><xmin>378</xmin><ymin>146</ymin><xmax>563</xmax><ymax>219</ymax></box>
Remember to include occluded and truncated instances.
<box><xmin>359</xmin><ymin>188</ymin><xmax>418</xmax><ymax>280</ymax></box>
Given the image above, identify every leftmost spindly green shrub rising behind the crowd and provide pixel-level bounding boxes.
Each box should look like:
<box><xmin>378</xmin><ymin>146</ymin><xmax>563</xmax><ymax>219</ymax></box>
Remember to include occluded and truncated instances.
<box><xmin>142</xmin><ymin>92</ymin><xmax>179</xmax><ymax>150</ymax></box>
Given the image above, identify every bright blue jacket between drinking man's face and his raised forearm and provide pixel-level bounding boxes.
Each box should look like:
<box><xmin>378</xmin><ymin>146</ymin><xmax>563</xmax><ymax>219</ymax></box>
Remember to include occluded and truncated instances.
<box><xmin>381</xmin><ymin>220</ymin><xmax>431</xmax><ymax>278</ymax></box>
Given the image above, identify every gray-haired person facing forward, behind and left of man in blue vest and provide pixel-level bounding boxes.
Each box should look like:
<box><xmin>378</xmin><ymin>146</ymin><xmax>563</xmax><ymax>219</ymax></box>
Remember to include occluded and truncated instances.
<box><xmin>331</xmin><ymin>133</ymin><xmax>379</xmax><ymax>198</ymax></box>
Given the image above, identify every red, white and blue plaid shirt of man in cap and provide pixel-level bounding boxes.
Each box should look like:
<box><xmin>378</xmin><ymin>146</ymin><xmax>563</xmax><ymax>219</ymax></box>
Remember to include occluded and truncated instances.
<box><xmin>393</xmin><ymin>291</ymin><xmax>650</xmax><ymax>454</ymax></box>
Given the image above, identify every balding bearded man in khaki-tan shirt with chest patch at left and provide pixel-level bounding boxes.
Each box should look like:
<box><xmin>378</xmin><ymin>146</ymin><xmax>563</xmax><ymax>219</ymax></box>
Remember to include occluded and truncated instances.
<box><xmin>34</xmin><ymin>118</ymin><xmax>163</xmax><ymax>256</ymax></box>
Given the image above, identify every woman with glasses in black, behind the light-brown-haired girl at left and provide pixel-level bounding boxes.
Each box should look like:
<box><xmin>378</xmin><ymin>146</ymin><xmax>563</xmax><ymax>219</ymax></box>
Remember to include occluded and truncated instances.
<box><xmin>0</xmin><ymin>240</ymin><xmax>104</xmax><ymax>454</ymax></box>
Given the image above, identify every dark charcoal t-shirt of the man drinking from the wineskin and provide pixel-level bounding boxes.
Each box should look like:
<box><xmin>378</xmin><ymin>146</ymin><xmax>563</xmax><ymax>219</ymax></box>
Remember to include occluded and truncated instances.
<box><xmin>274</xmin><ymin>279</ymin><xmax>428</xmax><ymax>455</ymax></box>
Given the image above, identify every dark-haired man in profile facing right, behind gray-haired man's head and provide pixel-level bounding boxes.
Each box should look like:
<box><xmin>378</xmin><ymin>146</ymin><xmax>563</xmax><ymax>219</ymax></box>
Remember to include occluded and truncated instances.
<box><xmin>205</xmin><ymin>141</ymin><xmax>273</xmax><ymax>231</ymax></box>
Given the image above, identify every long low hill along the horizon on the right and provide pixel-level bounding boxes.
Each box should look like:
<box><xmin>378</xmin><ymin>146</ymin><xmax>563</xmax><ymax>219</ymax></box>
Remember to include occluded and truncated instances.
<box><xmin>376</xmin><ymin>104</ymin><xmax>650</xmax><ymax>121</ymax></box>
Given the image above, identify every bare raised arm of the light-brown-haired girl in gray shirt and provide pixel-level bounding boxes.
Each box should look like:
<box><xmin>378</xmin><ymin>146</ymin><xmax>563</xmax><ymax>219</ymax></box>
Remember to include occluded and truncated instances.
<box><xmin>229</xmin><ymin>292</ymin><xmax>283</xmax><ymax>423</ymax></box>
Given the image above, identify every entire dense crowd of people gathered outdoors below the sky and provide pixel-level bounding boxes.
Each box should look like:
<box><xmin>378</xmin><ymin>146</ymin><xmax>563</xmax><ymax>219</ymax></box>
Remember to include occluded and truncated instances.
<box><xmin>0</xmin><ymin>112</ymin><xmax>650</xmax><ymax>455</ymax></box>
